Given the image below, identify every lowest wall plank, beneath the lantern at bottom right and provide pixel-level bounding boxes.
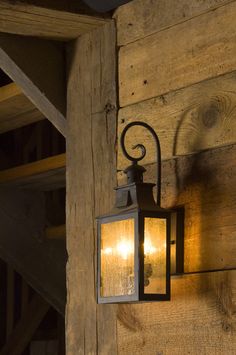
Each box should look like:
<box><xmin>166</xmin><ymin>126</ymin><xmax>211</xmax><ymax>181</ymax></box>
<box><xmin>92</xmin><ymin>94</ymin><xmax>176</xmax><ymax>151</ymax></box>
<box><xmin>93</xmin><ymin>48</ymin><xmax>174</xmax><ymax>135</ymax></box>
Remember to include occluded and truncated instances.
<box><xmin>117</xmin><ymin>271</ymin><xmax>236</xmax><ymax>355</ymax></box>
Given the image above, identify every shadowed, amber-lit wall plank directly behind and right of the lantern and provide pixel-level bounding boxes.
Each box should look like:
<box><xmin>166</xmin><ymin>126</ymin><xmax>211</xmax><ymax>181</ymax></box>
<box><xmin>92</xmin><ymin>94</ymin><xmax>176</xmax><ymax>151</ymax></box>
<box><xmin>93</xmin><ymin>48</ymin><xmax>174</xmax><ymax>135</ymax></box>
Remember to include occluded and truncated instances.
<box><xmin>118</xmin><ymin>145</ymin><xmax>236</xmax><ymax>272</ymax></box>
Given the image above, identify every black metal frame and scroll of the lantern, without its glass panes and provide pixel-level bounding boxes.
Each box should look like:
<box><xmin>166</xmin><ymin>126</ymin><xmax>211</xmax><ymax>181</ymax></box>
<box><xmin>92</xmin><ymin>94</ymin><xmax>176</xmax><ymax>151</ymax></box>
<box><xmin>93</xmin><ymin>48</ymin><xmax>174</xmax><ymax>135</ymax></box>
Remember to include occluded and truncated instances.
<box><xmin>97</xmin><ymin>121</ymin><xmax>175</xmax><ymax>303</ymax></box>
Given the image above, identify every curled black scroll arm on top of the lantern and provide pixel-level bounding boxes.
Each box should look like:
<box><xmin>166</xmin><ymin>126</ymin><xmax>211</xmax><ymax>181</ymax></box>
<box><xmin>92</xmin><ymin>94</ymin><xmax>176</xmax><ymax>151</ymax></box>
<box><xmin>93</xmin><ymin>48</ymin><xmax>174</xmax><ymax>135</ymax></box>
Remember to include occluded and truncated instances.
<box><xmin>120</xmin><ymin>121</ymin><xmax>161</xmax><ymax>206</ymax></box>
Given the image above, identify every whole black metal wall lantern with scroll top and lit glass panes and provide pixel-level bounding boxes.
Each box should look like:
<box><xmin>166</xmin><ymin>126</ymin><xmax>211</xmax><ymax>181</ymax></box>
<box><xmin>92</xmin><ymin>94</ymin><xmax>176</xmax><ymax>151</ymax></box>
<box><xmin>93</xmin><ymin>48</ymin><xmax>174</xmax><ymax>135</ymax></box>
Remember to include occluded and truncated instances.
<box><xmin>97</xmin><ymin>122</ymin><xmax>171</xmax><ymax>303</ymax></box>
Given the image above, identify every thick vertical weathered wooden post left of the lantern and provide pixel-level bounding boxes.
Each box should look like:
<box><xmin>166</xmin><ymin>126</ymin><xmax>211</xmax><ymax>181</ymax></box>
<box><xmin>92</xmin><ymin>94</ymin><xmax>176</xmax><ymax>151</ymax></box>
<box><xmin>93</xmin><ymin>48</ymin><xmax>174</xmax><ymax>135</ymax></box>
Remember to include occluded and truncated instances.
<box><xmin>66</xmin><ymin>22</ymin><xmax>117</xmax><ymax>355</ymax></box>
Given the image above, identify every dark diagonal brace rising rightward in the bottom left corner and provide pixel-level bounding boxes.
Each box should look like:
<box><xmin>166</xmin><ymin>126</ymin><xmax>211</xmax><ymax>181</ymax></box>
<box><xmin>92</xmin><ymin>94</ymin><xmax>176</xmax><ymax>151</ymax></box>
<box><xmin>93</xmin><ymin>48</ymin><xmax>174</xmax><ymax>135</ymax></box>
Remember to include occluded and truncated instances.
<box><xmin>0</xmin><ymin>294</ymin><xmax>50</xmax><ymax>355</ymax></box>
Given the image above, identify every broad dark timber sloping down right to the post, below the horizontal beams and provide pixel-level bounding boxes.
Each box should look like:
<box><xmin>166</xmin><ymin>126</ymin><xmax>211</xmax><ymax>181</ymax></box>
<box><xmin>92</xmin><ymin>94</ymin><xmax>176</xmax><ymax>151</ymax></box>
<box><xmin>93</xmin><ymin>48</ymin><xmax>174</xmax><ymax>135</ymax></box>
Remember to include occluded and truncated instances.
<box><xmin>0</xmin><ymin>188</ymin><xmax>66</xmax><ymax>314</ymax></box>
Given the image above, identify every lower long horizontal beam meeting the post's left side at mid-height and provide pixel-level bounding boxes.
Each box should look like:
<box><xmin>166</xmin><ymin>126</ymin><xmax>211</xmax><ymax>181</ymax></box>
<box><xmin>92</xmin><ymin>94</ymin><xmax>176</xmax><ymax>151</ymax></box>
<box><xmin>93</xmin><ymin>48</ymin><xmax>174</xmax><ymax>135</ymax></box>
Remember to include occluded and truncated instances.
<box><xmin>0</xmin><ymin>154</ymin><xmax>66</xmax><ymax>191</ymax></box>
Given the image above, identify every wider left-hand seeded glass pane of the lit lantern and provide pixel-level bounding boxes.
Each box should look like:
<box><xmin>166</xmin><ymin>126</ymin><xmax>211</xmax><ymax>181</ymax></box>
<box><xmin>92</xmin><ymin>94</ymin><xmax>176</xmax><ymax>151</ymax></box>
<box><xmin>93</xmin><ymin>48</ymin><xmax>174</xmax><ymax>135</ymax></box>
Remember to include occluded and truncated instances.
<box><xmin>101</xmin><ymin>218</ymin><xmax>135</xmax><ymax>297</ymax></box>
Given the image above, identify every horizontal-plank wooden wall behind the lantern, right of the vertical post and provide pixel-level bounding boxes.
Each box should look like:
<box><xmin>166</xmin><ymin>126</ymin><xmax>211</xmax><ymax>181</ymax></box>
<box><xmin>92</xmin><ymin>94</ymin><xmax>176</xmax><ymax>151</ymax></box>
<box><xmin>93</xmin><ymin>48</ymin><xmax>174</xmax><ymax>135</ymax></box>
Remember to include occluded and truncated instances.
<box><xmin>115</xmin><ymin>0</ymin><xmax>236</xmax><ymax>355</ymax></box>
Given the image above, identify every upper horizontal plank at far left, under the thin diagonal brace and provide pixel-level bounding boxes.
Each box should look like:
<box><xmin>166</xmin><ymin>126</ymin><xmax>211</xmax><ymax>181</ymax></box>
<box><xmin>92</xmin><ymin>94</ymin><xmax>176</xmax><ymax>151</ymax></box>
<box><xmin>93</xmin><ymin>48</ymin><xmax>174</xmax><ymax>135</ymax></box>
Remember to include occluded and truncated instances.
<box><xmin>0</xmin><ymin>83</ymin><xmax>44</xmax><ymax>133</ymax></box>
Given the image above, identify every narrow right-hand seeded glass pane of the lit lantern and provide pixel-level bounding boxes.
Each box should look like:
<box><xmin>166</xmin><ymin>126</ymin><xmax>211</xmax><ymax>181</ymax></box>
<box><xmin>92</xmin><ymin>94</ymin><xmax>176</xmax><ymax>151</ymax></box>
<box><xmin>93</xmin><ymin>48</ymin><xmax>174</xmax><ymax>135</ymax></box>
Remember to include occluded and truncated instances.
<box><xmin>144</xmin><ymin>217</ymin><xmax>167</xmax><ymax>294</ymax></box>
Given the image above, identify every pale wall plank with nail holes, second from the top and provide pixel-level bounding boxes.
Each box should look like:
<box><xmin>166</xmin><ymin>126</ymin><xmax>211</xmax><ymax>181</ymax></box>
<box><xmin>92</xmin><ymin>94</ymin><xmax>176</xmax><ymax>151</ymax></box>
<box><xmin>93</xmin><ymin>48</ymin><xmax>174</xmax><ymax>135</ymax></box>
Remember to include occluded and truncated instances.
<box><xmin>119</xmin><ymin>2</ymin><xmax>236</xmax><ymax>107</ymax></box>
